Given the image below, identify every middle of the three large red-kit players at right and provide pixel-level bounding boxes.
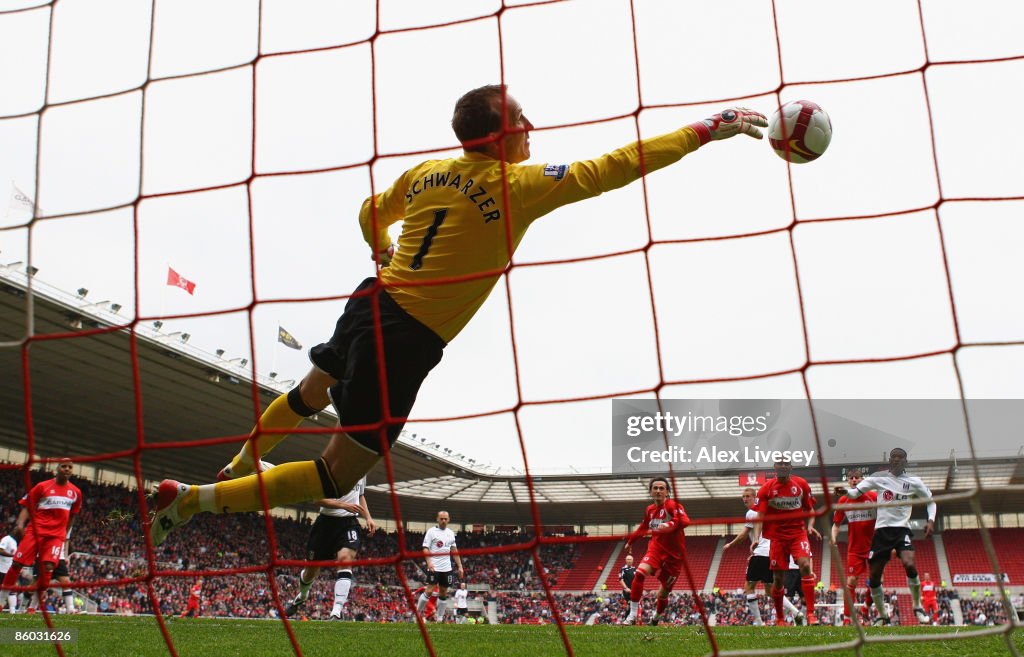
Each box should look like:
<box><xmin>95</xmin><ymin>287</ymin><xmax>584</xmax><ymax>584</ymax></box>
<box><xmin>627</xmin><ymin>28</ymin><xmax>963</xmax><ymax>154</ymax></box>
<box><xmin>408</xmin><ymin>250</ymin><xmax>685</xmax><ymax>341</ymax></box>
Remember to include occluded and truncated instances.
<box><xmin>752</xmin><ymin>461</ymin><xmax>821</xmax><ymax>625</ymax></box>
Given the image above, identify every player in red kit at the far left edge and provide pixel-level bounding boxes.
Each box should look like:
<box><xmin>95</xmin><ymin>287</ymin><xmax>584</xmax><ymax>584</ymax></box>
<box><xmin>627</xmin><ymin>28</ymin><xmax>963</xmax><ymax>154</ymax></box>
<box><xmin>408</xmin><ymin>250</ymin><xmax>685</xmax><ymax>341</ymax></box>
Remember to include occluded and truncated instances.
<box><xmin>0</xmin><ymin>458</ymin><xmax>82</xmax><ymax>610</ymax></box>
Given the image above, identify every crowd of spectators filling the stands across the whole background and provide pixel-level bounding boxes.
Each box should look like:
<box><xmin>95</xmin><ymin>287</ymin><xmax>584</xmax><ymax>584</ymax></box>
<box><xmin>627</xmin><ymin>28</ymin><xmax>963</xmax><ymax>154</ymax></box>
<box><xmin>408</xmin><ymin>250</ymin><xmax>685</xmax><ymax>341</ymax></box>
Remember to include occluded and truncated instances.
<box><xmin>0</xmin><ymin>470</ymin><xmax>1007</xmax><ymax>625</ymax></box>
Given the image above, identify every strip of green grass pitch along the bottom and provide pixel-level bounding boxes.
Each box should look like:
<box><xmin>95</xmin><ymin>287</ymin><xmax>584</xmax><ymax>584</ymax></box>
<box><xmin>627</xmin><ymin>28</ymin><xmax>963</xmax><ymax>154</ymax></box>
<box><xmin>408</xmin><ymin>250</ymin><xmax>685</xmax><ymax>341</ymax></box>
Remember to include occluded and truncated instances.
<box><xmin>0</xmin><ymin>614</ymin><xmax>1024</xmax><ymax>657</ymax></box>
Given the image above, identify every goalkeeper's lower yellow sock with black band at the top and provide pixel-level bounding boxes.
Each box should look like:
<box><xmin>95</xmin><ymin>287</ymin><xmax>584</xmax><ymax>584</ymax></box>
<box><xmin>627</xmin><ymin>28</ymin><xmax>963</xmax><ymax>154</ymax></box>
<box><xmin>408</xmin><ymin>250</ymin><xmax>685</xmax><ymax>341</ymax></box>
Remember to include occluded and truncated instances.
<box><xmin>178</xmin><ymin>459</ymin><xmax>331</xmax><ymax>518</ymax></box>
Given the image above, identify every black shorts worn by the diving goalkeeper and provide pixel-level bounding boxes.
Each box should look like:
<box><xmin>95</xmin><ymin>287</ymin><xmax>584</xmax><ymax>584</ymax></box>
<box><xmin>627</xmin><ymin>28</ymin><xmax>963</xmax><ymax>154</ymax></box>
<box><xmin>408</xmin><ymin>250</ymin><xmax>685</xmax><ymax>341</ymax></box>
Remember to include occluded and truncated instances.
<box><xmin>309</xmin><ymin>278</ymin><xmax>445</xmax><ymax>453</ymax></box>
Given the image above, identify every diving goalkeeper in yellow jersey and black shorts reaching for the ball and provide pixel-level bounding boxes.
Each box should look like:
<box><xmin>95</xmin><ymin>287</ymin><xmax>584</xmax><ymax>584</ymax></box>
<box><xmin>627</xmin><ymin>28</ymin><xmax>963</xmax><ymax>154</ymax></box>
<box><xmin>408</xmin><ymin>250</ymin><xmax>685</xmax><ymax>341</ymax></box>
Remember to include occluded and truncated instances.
<box><xmin>151</xmin><ymin>85</ymin><xmax>768</xmax><ymax>545</ymax></box>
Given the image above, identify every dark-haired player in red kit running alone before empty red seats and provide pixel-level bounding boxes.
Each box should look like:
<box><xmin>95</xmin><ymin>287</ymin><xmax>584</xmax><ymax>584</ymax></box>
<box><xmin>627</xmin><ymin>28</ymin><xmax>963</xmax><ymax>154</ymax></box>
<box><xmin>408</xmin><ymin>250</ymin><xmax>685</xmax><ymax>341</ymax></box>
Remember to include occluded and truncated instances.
<box><xmin>623</xmin><ymin>477</ymin><xmax>690</xmax><ymax>625</ymax></box>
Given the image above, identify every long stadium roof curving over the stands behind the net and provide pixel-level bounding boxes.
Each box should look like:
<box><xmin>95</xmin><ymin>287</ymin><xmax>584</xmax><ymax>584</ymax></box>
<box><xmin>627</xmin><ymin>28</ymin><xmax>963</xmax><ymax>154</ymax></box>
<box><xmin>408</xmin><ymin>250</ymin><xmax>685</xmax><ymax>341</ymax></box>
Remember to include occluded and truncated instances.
<box><xmin>0</xmin><ymin>266</ymin><xmax>1024</xmax><ymax>525</ymax></box>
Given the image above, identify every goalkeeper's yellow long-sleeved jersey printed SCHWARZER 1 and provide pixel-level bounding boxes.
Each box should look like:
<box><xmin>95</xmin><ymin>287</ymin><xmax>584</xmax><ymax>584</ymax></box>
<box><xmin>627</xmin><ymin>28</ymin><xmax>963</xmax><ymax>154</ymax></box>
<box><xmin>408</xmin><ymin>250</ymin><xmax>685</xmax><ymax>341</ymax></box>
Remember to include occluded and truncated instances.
<box><xmin>359</xmin><ymin>127</ymin><xmax>700</xmax><ymax>343</ymax></box>
